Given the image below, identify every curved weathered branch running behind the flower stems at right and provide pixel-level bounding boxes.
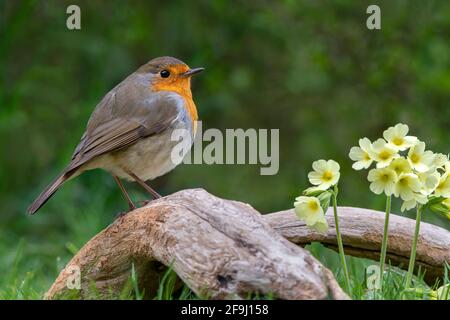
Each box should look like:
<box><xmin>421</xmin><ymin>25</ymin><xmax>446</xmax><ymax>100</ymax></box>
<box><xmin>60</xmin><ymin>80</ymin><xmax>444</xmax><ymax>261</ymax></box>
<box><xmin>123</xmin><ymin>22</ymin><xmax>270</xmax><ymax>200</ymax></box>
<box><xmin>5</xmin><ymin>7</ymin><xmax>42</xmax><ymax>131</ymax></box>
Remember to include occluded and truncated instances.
<box><xmin>264</xmin><ymin>207</ymin><xmax>450</xmax><ymax>284</ymax></box>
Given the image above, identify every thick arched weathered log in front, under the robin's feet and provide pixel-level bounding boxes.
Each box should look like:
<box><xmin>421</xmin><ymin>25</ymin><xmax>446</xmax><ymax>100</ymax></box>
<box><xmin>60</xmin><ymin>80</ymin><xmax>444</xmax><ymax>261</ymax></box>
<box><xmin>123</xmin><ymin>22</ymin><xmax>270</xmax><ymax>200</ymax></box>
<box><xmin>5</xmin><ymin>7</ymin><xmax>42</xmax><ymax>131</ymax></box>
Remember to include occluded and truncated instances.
<box><xmin>46</xmin><ymin>189</ymin><xmax>348</xmax><ymax>299</ymax></box>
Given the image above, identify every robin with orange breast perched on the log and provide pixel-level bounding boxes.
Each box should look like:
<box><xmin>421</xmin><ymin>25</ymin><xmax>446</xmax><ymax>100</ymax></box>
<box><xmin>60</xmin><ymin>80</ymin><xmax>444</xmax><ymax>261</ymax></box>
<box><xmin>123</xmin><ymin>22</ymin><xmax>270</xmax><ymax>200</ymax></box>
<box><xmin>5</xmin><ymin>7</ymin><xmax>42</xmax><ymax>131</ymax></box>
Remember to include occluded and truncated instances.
<box><xmin>28</xmin><ymin>57</ymin><xmax>204</xmax><ymax>214</ymax></box>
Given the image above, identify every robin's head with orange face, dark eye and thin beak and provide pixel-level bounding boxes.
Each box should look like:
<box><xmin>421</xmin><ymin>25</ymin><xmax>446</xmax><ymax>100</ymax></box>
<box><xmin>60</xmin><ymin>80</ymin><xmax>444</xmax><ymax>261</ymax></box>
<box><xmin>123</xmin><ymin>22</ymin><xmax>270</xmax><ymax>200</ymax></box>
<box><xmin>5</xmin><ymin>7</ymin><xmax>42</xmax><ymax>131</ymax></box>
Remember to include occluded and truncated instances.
<box><xmin>138</xmin><ymin>57</ymin><xmax>204</xmax><ymax>97</ymax></box>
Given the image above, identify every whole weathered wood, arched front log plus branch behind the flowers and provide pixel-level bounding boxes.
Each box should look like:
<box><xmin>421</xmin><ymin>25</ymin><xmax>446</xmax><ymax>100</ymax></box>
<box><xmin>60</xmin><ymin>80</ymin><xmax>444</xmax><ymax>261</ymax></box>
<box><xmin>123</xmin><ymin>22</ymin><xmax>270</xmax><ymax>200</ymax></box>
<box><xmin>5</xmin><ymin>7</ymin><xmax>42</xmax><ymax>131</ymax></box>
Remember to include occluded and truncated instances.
<box><xmin>45</xmin><ymin>189</ymin><xmax>450</xmax><ymax>299</ymax></box>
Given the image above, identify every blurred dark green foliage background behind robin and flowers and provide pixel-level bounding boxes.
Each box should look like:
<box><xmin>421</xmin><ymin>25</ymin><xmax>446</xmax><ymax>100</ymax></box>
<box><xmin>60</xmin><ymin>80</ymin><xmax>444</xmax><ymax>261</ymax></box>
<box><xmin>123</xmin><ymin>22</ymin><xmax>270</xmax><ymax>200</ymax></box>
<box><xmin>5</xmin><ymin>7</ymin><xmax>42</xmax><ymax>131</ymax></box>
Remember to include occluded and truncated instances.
<box><xmin>0</xmin><ymin>0</ymin><xmax>450</xmax><ymax>298</ymax></box>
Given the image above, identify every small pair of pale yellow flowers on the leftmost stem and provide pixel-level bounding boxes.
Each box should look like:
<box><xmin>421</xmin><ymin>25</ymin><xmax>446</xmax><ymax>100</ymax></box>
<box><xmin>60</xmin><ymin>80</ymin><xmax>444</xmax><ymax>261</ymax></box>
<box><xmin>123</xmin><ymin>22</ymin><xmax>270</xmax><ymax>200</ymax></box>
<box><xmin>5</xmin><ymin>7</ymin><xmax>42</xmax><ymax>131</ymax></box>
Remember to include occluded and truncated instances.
<box><xmin>294</xmin><ymin>160</ymin><xmax>340</xmax><ymax>232</ymax></box>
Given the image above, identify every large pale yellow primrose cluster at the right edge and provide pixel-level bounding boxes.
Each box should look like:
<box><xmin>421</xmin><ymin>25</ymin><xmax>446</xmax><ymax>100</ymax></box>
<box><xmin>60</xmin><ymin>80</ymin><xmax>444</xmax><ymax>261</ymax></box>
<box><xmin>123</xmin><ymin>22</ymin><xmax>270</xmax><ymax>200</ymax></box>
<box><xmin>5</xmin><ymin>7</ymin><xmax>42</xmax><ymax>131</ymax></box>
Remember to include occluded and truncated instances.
<box><xmin>349</xmin><ymin>123</ymin><xmax>450</xmax><ymax>216</ymax></box>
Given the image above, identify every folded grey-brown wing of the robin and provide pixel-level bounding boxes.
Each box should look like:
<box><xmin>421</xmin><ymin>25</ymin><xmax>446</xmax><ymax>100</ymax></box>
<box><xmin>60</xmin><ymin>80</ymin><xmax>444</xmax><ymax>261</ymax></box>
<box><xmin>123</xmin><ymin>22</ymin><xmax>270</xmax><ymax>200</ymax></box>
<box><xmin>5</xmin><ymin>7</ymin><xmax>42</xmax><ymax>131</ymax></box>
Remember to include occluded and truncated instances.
<box><xmin>66</xmin><ymin>92</ymin><xmax>183</xmax><ymax>171</ymax></box>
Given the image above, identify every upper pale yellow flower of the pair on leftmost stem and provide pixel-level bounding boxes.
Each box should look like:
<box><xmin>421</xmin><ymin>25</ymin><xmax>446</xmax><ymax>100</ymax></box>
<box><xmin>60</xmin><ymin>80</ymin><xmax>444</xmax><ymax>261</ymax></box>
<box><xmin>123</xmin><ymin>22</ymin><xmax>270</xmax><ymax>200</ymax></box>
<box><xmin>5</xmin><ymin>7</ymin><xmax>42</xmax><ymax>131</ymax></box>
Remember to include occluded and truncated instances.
<box><xmin>308</xmin><ymin>160</ymin><xmax>341</xmax><ymax>190</ymax></box>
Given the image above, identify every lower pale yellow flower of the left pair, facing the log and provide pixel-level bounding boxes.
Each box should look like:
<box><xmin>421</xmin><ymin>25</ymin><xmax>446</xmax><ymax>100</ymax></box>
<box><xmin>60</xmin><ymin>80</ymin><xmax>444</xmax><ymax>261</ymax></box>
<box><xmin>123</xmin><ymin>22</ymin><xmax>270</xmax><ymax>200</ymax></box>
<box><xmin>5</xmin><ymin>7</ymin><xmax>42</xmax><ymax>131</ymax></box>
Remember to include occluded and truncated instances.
<box><xmin>294</xmin><ymin>196</ymin><xmax>328</xmax><ymax>232</ymax></box>
